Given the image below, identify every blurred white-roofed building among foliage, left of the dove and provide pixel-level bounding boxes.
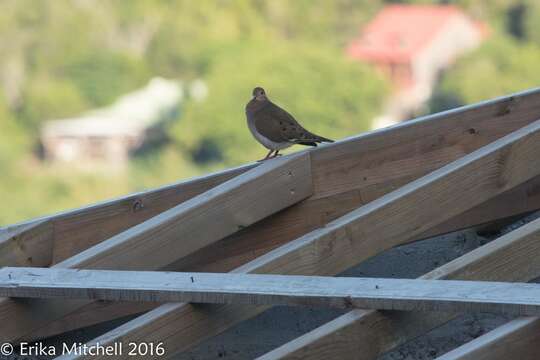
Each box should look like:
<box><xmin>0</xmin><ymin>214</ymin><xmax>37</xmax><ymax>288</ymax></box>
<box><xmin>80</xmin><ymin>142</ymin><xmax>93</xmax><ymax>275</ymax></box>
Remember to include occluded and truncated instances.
<box><xmin>41</xmin><ymin>78</ymin><xmax>183</xmax><ymax>165</ymax></box>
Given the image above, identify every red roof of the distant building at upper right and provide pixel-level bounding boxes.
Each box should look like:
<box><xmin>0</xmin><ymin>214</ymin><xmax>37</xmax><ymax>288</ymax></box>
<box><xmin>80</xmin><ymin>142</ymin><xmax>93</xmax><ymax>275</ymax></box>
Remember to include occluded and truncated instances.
<box><xmin>347</xmin><ymin>5</ymin><xmax>474</xmax><ymax>62</ymax></box>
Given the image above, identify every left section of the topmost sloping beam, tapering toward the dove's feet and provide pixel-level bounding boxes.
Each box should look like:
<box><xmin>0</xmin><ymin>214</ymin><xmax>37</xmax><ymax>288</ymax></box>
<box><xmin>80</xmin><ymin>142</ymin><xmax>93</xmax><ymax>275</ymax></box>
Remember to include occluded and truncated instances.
<box><xmin>0</xmin><ymin>164</ymin><xmax>256</xmax><ymax>266</ymax></box>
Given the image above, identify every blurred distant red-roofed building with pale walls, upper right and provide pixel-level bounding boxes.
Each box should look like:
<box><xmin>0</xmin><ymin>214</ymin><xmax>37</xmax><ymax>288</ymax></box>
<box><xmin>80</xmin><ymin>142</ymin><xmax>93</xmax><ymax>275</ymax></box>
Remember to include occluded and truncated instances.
<box><xmin>347</xmin><ymin>5</ymin><xmax>487</xmax><ymax>128</ymax></box>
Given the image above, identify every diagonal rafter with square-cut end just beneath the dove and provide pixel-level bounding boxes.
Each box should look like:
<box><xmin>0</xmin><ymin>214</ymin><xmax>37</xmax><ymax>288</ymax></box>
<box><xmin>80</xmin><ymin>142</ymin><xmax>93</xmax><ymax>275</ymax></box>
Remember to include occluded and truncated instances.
<box><xmin>0</xmin><ymin>153</ymin><xmax>312</xmax><ymax>340</ymax></box>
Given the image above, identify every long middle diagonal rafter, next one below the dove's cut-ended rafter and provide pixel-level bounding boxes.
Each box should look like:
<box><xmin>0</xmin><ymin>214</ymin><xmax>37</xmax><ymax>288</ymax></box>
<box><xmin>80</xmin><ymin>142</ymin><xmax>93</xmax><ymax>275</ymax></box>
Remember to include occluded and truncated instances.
<box><xmin>65</xmin><ymin>117</ymin><xmax>540</xmax><ymax>354</ymax></box>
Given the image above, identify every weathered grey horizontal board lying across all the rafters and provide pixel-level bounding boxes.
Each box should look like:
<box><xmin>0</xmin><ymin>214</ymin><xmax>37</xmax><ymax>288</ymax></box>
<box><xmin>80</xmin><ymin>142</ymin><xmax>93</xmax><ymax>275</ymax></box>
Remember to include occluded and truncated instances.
<box><xmin>5</xmin><ymin>267</ymin><xmax>540</xmax><ymax>316</ymax></box>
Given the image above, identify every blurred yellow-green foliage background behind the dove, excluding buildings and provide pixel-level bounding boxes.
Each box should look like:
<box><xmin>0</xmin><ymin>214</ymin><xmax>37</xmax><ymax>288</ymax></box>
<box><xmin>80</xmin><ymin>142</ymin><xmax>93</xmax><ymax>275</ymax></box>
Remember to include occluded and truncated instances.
<box><xmin>0</xmin><ymin>0</ymin><xmax>540</xmax><ymax>226</ymax></box>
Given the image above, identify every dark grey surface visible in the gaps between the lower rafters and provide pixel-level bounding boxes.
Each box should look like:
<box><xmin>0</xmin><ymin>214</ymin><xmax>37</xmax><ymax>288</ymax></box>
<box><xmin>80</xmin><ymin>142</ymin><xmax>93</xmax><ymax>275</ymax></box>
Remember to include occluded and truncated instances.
<box><xmin>0</xmin><ymin>215</ymin><xmax>538</xmax><ymax>360</ymax></box>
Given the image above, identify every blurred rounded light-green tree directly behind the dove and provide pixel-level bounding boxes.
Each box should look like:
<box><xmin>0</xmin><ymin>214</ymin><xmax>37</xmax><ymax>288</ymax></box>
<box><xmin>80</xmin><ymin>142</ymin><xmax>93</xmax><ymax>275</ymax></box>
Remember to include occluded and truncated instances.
<box><xmin>173</xmin><ymin>40</ymin><xmax>387</xmax><ymax>165</ymax></box>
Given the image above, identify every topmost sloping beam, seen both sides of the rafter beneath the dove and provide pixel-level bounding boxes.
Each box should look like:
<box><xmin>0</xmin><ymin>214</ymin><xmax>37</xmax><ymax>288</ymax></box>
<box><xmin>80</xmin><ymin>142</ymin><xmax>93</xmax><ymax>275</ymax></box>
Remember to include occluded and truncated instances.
<box><xmin>0</xmin><ymin>89</ymin><xmax>540</xmax><ymax>267</ymax></box>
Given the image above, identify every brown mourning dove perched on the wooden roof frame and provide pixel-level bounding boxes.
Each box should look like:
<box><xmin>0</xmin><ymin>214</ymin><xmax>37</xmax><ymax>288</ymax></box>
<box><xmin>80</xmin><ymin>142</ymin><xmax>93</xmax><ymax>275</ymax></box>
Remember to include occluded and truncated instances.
<box><xmin>246</xmin><ymin>87</ymin><xmax>334</xmax><ymax>160</ymax></box>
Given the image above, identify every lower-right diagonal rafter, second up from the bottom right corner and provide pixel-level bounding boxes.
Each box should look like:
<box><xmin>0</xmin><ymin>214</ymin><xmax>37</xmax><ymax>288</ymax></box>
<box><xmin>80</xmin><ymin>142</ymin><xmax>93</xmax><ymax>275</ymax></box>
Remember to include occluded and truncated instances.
<box><xmin>260</xmin><ymin>212</ymin><xmax>540</xmax><ymax>360</ymax></box>
